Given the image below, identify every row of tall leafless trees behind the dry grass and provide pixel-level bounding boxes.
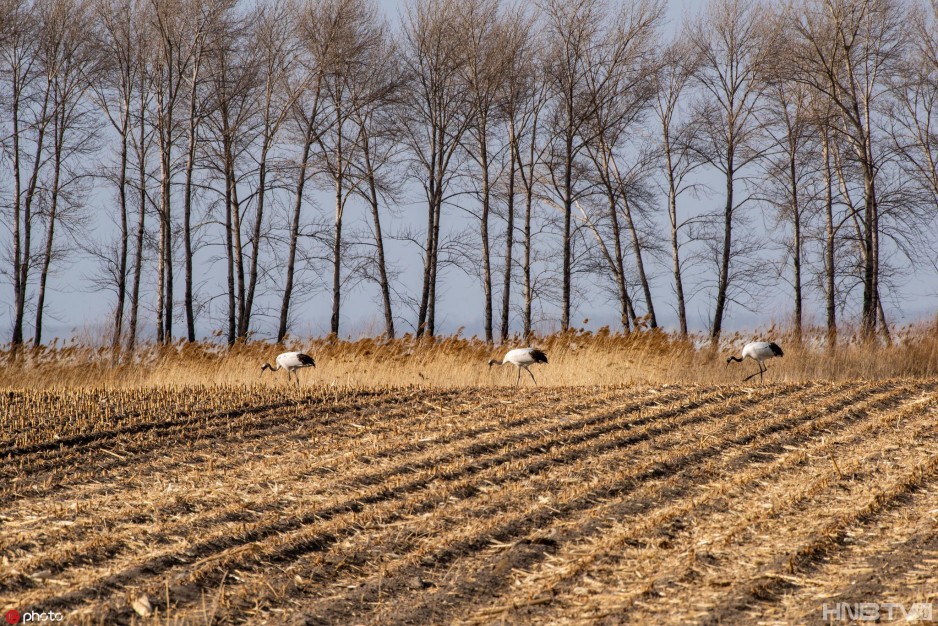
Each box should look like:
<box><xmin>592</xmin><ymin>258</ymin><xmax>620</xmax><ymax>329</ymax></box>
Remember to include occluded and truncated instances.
<box><xmin>0</xmin><ymin>0</ymin><xmax>938</xmax><ymax>349</ymax></box>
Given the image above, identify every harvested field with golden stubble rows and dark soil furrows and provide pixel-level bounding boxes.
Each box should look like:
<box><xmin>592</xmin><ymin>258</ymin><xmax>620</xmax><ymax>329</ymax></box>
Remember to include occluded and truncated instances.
<box><xmin>0</xmin><ymin>380</ymin><xmax>938</xmax><ymax>624</ymax></box>
